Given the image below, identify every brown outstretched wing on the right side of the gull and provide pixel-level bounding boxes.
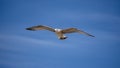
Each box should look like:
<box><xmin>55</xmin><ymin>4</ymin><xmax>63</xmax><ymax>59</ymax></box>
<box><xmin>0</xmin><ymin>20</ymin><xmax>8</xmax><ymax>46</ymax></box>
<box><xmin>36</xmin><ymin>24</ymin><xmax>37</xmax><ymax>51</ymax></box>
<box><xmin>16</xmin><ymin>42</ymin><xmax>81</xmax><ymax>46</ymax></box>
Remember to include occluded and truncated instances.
<box><xmin>62</xmin><ymin>28</ymin><xmax>94</xmax><ymax>37</ymax></box>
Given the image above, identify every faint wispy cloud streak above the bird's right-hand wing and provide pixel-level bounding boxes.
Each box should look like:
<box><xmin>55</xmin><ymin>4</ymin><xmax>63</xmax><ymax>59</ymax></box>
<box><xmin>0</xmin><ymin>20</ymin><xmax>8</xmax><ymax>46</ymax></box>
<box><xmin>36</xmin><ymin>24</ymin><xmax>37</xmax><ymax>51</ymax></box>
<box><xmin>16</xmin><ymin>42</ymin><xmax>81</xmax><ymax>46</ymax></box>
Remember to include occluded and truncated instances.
<box><xmin>46</xmin><ymin>10</ymin><xmax>120</xmax><ymax>22</ymax></box>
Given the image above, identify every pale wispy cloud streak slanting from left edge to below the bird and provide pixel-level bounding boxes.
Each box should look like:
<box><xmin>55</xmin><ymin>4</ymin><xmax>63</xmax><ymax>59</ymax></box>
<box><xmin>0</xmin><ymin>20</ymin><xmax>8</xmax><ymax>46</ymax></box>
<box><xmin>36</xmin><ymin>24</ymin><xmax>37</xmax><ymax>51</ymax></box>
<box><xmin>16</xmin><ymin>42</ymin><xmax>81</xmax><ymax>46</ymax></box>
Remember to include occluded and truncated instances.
<box><xmin>0</xmin><ymin>35</ymin><xmax>71</xmax><ymax>46</ymax></box>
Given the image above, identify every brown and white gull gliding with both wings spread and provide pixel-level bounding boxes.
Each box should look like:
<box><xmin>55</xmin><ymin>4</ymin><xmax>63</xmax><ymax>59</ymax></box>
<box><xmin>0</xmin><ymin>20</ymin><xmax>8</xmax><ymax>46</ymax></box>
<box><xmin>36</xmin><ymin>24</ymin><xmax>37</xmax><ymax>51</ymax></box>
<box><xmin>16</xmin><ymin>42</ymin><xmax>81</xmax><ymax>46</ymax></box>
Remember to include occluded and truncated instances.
<box><xmin>26</xmin><ymin>25</ymin><xmax>95</xmax><ymax>40</ymax></box>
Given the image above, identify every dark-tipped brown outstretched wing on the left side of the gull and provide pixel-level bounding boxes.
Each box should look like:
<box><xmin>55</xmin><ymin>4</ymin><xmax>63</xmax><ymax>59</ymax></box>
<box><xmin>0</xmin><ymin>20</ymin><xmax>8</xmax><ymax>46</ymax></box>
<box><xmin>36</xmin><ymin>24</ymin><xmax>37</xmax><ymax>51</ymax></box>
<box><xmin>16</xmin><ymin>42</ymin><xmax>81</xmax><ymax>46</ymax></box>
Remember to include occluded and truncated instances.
<box><xmin>26</xmin><ymin>25</ymin><xmax>55</xmax><ymax>32</ymax></box>
